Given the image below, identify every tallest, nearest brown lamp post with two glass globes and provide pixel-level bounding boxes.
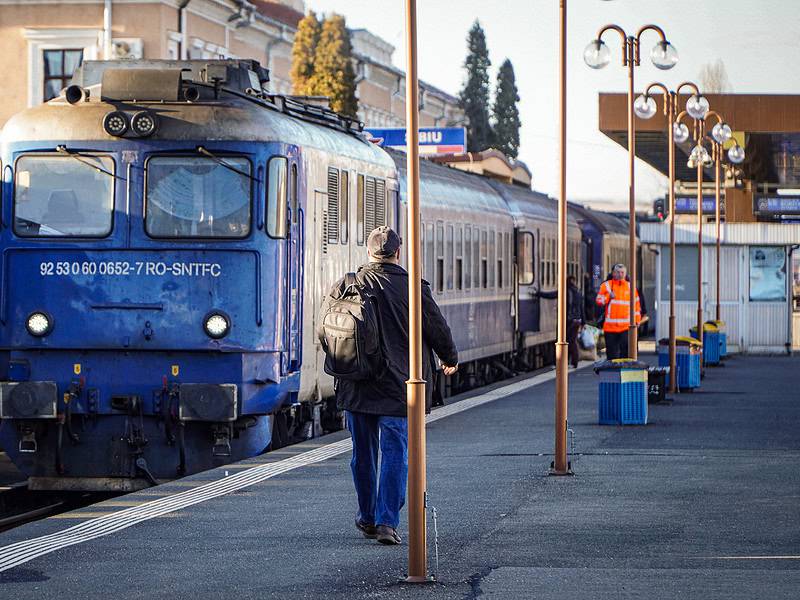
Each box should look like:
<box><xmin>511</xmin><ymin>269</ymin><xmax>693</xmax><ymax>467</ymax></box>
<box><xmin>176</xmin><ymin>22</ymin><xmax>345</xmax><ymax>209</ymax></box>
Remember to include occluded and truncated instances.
<box><xmin>583</xmin><ymin>25</ymin><xmax>678</xmax><ymax>360</ymax></box>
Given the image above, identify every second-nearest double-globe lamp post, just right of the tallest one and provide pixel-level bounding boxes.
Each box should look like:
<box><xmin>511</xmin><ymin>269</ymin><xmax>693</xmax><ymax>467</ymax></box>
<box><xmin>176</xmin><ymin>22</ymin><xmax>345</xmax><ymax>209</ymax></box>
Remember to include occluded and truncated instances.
<box><xmin>633</xmin><ymin>81</ymin><xmax>708</xmax><ymax>394</ymax></box>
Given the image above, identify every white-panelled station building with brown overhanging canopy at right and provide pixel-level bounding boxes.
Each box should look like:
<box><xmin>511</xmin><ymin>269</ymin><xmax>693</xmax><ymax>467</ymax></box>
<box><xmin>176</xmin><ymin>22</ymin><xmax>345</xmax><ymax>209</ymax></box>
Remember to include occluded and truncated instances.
<box><xmin>599</xmin><ymin>93</ymin><xmax>800</xmax><ymax>353</ymax></box>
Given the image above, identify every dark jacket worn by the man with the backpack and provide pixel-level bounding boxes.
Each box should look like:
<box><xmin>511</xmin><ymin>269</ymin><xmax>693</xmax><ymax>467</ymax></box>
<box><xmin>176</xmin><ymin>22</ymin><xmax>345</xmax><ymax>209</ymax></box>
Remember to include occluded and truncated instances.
<box><xmin>317</xmin><ymin>262</ymin><xmax>458</xmax><ymax>417</ymax></box>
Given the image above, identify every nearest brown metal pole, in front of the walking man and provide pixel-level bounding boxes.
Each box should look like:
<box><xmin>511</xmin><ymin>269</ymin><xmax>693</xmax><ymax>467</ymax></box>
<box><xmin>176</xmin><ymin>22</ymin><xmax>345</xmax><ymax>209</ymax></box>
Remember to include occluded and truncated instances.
<box><xmin>406</xmin><ymin>0</ymin><xmax>428</xmax><ymax>583</ymax></box>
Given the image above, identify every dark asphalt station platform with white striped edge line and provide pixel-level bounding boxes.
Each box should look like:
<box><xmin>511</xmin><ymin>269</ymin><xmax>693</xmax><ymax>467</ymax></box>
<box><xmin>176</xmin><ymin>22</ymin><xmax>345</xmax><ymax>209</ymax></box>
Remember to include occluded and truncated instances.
<box><xmin>0</xmin><ymin>356</ymin><xmax>800</xmax><ymax>600</ymax></box>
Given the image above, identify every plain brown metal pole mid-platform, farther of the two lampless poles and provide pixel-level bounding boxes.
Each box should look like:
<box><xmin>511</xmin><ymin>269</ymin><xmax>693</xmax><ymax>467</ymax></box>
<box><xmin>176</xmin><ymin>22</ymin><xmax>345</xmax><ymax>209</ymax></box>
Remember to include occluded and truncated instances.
<box><xmin>553</xmin><ymin>0</ymin><xmax>569</xmax><ymax>475</ymax></box>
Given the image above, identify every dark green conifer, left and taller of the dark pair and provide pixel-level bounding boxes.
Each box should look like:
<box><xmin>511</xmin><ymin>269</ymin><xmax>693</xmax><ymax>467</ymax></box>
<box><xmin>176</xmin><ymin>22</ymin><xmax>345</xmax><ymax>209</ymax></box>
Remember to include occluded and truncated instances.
<box><xmin>460</xmin><ymin>20</ymin><xmax>492</xmax><ymax>152</ymax></box>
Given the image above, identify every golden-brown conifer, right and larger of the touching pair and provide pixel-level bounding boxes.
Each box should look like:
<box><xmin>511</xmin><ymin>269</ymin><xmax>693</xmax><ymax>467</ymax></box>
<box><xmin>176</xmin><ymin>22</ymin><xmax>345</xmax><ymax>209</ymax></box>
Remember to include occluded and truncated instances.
<box><xmin>309</xmin><ymin>15</ymin><xmax>358</xmax><ymax>117</ymax></box>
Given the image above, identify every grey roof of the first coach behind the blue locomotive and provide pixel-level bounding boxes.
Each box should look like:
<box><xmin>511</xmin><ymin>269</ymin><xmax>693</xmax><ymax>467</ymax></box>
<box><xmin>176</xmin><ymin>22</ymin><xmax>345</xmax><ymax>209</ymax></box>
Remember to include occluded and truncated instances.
<box><xmin>387</xmin><ymin>150</ymin><xmax>508</xmax><ymax>214</ymax></box>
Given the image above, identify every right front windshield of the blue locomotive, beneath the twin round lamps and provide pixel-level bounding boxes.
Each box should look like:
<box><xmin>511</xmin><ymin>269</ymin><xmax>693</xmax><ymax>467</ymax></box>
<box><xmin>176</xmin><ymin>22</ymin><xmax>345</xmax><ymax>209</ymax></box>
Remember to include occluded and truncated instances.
<box><xmin>145</xmin><ymin>156</ymin><xmax>251</xmax><ymax>238</ymax></box>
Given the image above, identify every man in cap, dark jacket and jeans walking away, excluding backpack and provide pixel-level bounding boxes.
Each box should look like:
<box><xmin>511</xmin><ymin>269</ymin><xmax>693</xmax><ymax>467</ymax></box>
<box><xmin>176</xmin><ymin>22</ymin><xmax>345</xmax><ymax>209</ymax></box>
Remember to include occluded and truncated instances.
<box><xmin>320</xmin><ymin>227</ymin><xmax>458</xmax><ymax>545</ymax></box>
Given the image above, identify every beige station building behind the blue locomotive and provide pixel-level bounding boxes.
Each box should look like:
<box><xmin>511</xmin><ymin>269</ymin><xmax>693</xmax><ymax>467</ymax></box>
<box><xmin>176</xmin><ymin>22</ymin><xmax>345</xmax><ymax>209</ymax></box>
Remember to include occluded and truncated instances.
<box><xmin>0</xmin><ymin>0</ymin><xmax>464</xmax><ymax>127</ymax></box>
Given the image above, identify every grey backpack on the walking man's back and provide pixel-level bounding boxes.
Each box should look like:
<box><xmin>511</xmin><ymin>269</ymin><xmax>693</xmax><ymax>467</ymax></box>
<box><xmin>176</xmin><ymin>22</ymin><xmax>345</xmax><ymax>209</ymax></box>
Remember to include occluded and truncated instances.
<box><xmin>319</xmin><ymin>273</ymin><xmax>383</xmax><ymax>380</ymax></box>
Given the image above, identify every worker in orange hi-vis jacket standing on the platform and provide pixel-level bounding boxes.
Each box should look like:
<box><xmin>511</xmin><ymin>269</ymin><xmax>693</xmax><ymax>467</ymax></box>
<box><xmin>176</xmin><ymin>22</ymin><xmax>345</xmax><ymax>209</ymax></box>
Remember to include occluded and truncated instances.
<box><xmin>596</xmin><ymin>264</ymin><xmax>642</xmax><ymax>360</ymax></box>
